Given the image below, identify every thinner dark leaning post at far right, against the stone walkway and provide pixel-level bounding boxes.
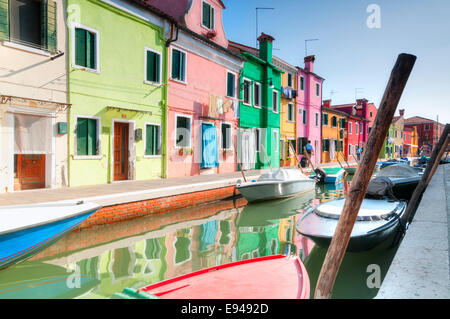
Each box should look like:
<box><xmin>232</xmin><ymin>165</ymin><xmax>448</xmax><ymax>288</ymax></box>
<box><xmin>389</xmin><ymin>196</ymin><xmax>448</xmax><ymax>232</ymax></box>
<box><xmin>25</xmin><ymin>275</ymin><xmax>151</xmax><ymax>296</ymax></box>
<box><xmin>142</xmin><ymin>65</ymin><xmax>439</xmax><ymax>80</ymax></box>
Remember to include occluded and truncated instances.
<box><xmin>395</xmin><ymin>124</ymin><xmax>450</xmax><ymax>228</ymax></box>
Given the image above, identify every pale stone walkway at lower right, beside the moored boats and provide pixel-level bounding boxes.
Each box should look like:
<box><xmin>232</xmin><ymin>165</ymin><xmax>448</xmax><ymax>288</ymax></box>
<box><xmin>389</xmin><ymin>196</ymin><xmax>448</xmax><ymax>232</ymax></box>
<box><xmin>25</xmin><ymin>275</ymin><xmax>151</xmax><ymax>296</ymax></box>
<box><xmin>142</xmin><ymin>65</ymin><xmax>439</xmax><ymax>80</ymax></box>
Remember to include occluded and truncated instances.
<box><xmin>377</xmin><ymin>164</ymin><xmax>450</xmax><ymax>299</ymax></box>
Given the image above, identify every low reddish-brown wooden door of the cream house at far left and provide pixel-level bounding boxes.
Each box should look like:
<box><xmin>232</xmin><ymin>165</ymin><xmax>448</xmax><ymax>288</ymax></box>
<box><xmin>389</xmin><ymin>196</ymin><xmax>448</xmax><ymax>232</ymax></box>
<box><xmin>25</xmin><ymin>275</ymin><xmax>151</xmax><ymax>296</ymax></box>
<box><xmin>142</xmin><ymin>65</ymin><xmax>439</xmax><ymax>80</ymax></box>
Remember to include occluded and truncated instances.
<box><xmin>14</xmin><ymin>154</ymin><xmax>45</xmax><ymax>190</ymax></box>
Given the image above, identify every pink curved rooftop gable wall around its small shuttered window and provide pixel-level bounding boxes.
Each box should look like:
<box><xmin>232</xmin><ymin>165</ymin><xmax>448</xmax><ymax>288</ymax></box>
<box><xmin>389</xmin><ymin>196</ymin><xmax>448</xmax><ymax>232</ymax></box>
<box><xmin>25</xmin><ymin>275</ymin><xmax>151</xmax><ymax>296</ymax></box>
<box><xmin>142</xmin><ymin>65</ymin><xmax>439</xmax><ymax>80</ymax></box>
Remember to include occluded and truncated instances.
<box><xmin>185</xmin><ymin>0</ymin><xmax>228</xmax><ymax>48</ymax></box>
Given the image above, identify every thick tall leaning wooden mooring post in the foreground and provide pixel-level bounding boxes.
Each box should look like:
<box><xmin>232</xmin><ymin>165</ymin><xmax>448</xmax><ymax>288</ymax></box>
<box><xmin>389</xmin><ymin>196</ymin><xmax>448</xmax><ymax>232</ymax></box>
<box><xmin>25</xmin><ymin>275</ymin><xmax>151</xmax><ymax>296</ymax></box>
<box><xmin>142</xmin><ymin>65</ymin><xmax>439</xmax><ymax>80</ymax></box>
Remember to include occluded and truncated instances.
<box><xmin>314</xmin><ymin>54</ymin><xmax>416</xmax><ymax>299</ymax></box>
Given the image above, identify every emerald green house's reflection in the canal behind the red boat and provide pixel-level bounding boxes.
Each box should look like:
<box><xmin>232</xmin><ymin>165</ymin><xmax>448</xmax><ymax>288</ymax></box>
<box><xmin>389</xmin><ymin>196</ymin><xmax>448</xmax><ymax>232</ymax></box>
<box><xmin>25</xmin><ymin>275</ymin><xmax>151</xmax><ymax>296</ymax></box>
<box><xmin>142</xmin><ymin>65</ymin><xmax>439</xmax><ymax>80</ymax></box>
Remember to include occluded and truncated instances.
<box><xmin>237</xmin><ymin>224</ymin><xmax>280</xmax><ymax>260</ymax></box>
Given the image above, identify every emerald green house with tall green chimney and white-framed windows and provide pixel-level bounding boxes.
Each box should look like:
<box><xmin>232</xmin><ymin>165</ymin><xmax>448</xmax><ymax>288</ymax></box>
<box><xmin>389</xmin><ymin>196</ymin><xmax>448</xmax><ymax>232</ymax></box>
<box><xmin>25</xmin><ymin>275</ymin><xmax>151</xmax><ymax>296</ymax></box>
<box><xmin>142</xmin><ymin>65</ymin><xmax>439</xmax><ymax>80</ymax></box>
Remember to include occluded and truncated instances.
<box><xmin>229</xmin><ymin>33</ymin><xmax>283</xmax><ymax>169</ymax></box>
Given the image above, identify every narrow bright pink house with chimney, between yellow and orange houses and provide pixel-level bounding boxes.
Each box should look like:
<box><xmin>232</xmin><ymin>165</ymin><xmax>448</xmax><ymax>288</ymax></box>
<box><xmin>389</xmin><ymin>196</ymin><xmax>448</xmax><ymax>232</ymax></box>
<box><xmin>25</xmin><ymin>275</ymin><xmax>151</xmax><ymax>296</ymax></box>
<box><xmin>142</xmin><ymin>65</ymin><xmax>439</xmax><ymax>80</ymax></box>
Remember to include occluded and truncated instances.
<box><xmin>297</xmin><ymin>55</ymin><xmax>324</xmax><ymax>165</ymax></box>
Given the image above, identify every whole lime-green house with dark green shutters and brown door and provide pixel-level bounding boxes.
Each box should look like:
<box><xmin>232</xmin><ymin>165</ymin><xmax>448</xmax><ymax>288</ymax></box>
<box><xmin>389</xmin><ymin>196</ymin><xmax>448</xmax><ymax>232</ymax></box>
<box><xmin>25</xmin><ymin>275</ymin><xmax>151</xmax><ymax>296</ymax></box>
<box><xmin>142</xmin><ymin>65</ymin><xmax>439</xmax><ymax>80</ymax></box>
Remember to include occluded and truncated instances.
<box><xmin>67</xmin><ymin>0</ymin><xmax>170</xmax><ymax>186</ymax></box>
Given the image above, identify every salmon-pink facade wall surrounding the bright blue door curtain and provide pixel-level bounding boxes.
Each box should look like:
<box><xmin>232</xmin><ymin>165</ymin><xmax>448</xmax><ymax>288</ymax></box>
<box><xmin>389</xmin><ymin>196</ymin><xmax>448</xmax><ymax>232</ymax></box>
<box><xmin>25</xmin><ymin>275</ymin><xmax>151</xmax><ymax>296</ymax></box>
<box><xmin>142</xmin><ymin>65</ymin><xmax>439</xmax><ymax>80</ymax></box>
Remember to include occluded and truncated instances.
<box><xmin>167</xmin><ymin>46</ymin><xmax>239</xmax><ymax>178</ymax></box>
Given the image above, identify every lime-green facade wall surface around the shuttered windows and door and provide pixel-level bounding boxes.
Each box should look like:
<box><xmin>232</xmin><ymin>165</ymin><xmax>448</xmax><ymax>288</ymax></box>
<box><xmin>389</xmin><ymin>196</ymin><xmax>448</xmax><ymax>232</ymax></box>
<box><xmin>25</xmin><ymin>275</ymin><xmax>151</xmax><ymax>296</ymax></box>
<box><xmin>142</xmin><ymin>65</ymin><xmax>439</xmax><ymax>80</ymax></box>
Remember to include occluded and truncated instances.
<box><xmin>67</xmin><ymin>0</ymin><xmax>168</xmax><ymax>186</ymax></box>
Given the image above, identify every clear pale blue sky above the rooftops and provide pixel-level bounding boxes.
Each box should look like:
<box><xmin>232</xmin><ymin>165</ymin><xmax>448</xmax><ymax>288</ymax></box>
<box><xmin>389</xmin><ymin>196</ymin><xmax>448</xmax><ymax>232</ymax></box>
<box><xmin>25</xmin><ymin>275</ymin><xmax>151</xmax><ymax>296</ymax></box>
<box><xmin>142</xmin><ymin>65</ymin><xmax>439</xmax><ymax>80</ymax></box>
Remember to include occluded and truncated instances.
<box><xmin>223</xmin><ymin>0</ymin><xmax>450</xmax><ymax>123</ymax></box>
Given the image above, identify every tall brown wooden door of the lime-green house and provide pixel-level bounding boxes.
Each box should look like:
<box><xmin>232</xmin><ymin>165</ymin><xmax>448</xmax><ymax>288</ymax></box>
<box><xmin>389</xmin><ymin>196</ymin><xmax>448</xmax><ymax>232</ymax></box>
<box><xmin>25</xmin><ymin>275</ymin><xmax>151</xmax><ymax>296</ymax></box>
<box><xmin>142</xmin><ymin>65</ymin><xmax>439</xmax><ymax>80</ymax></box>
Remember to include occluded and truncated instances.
<box><xmin>114</xmin><ymin>123</ymin><xmax>129</xmax><ymax>181</ymax></box>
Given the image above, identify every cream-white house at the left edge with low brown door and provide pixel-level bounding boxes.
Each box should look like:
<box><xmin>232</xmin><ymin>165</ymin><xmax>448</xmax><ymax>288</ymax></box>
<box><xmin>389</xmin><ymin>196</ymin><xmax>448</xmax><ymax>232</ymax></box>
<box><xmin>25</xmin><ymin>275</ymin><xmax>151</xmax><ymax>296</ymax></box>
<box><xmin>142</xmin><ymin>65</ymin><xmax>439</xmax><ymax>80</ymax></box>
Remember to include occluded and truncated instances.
<box><xmin>0</xmin><ymin>0</ymin><xmax>70</xmax><ymax>193</ymax></box>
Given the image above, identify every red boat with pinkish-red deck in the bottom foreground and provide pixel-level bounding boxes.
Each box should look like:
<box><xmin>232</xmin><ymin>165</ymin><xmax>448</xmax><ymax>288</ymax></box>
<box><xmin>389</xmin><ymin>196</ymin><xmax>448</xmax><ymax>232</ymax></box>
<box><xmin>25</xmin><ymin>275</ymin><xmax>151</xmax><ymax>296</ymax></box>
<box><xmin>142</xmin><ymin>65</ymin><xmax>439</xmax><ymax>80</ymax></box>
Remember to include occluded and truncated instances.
<box><xmin>115</xmin><ymin>255</ymin><xmax>310</xmax><ymax>299</ymax></box>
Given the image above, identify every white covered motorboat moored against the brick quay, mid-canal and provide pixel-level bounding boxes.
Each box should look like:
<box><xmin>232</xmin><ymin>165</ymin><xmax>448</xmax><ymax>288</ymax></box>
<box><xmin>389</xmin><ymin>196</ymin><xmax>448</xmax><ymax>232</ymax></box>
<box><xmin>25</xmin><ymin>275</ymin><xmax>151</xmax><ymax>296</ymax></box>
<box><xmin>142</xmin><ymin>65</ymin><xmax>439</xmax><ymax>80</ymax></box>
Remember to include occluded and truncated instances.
<box><xmin>236</xmin><ymin>168</ymin><xmax>315</xmax><ymax>202</ymax></box>
